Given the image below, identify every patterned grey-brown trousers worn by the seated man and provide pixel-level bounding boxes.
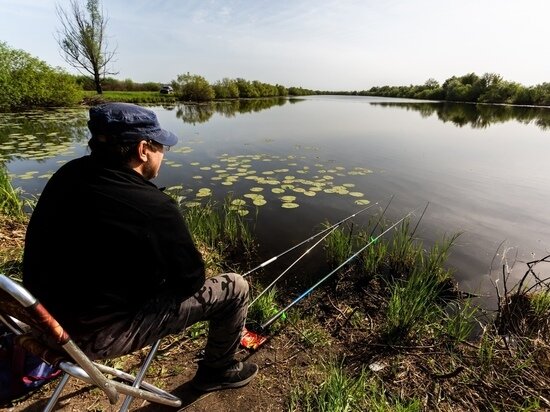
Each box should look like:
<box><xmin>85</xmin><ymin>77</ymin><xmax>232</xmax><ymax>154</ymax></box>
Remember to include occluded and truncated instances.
<box><xmin>77</xmin><ymin>273</ymin><xmax>249</xmax><ymax>367</ymax></box>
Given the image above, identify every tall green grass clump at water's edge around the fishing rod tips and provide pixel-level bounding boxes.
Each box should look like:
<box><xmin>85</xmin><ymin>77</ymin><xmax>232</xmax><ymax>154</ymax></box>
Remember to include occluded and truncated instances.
<box><xmin>325</xmin><ymin>219</ymin><xmax>468</xmax><ymax>344</ymax></box>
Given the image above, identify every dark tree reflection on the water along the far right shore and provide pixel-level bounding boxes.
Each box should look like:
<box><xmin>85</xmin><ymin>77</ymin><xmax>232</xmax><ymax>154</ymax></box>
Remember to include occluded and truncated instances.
<box><xmin>371</xmin><ymin>102</ymin><xmax>550</xmax><ymax>130</ymax></box>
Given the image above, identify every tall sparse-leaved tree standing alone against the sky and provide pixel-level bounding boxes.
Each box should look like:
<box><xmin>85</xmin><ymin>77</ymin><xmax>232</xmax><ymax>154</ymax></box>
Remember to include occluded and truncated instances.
<box><xmin>55</xmin><ymin>0</ymin><xmax>118</xmax><ymax>94</ymax></box>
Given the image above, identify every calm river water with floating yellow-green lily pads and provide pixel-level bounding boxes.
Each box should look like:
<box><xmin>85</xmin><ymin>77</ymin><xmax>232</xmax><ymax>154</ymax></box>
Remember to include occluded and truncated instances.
<box><xmin>0</xmin><ymin>96</ymin><xmax>550</xmax><ymax>308</ymax></box>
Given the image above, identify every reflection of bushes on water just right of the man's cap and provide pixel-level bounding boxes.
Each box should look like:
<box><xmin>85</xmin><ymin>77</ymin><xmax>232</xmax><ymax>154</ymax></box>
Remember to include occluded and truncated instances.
<box><xmin>176</xmin><ymin>97</ymin><xmax>303</xmax><ymax>125</ymax></box>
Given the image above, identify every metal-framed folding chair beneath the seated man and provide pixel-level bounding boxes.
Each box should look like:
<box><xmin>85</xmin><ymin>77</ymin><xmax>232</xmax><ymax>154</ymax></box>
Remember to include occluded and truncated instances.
<box><xmin>0</xmin><ymin>274</ymin><xmax>181</xmax><ymax>411</ymax></box>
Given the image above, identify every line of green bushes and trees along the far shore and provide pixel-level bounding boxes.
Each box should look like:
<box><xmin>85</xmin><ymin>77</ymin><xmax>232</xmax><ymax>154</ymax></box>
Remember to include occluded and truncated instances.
<box><xmin>0</xmin><ymin>42</ymin><xmax>550</xmax><ymax>110</ymax></box>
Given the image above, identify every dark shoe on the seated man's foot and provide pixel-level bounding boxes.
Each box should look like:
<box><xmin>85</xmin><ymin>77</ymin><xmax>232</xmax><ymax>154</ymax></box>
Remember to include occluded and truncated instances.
<box><xmin>191</xmin><ymin>361</ymin><xmax>258</xmax><ymax>392</ymax></box>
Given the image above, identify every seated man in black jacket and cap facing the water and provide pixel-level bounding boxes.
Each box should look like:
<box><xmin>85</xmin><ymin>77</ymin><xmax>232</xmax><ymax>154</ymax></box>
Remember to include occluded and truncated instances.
<box><xmin>23</xmin><ymin>103</ymin><xmax>258</xmax><ymax>391</ymax></box>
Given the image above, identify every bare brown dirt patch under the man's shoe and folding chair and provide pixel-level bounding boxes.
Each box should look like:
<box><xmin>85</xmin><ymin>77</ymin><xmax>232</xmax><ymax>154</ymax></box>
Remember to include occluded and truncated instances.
<box><xmin>0</xmin><ymin>324</ymin><xmax>327</xmax><ymax>412</ymax></box>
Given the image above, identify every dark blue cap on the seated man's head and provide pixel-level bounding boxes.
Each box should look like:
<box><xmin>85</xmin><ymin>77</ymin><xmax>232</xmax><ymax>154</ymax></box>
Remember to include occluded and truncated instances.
<box><xmin>88</xmin><ymin>103</ymin><xmax>178</xmax><ymax>146</ymax></box>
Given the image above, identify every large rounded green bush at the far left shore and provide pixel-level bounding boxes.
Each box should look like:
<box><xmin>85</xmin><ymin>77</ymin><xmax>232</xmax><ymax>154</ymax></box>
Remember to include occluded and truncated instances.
<box><xmin>0</xmin><ymin>42</ymin><xmax>81</xmax><ymax>110</ymax></box>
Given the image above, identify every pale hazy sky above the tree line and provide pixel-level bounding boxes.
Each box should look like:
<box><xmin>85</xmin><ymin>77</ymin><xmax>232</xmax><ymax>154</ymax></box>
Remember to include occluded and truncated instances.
<box><xmin>0</xmin><ymin>0</ymin><xmax>550</xmax><ymax>91</ymax></box>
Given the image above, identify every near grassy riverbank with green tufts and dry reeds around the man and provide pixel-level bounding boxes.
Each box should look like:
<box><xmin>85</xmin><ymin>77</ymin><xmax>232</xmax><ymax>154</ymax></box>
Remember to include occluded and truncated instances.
<box><xmin>0</xmin><ymin>179</ymin><xmax>550</xmax><ymax>411</ymax></box>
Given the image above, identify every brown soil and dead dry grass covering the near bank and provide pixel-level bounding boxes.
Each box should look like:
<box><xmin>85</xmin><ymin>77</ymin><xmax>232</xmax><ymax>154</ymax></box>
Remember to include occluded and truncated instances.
<box><xmin>0</xmin><ymin>217</ymin><xmax>550</xmax><ymax>412</ymax></box>
